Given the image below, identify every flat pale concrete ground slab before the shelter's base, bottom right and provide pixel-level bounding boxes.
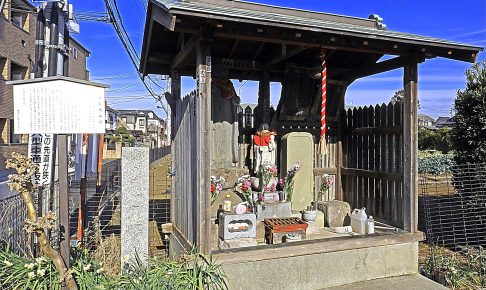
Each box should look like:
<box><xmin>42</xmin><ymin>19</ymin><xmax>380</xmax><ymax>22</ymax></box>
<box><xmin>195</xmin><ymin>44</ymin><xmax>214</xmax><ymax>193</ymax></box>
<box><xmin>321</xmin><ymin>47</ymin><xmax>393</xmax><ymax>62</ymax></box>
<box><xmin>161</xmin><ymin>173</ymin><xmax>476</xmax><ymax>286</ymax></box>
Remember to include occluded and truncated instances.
<box><xmin>323</xmin><ymin>274</ymin><xmax>448</xmax><ymax>290</ymax></box>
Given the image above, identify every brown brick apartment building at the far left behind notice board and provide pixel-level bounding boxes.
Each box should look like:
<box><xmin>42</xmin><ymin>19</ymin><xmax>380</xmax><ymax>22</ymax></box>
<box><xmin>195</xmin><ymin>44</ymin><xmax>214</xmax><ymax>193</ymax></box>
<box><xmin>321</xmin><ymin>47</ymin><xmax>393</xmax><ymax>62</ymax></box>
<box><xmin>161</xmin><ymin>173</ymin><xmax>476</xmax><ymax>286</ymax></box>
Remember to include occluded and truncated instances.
<box><xmin>0</xmin><ymin>0</ymin><xmax>91</xmax><ymax>170</ymax></box>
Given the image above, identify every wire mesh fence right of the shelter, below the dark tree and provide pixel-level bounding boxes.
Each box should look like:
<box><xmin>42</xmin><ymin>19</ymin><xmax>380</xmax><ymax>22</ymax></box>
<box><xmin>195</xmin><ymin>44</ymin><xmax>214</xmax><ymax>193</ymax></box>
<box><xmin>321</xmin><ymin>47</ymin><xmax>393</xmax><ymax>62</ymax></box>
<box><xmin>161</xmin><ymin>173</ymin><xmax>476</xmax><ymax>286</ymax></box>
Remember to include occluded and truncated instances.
<box><xmin>419</xmin><ymin>164</ymin><xmax>486</xmax><ymax>289</ymax></box>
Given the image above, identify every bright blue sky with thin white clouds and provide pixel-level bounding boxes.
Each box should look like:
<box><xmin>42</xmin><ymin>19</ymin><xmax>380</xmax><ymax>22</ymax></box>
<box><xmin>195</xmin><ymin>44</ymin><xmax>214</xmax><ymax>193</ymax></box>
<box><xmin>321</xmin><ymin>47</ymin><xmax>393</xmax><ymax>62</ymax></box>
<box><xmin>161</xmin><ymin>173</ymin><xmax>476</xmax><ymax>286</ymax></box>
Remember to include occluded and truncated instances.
<box><xmin>66</xmin><ymin>0</ymin><xmax>486</xmax><ymax>117</ymax></box>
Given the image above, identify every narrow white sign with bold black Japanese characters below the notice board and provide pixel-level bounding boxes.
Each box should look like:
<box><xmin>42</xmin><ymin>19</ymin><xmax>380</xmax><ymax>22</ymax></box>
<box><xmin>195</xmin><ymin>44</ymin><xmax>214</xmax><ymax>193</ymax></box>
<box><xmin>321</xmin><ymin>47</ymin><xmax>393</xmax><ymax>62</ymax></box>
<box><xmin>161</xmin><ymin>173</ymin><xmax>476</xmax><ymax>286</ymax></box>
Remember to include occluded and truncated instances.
<box><xmin>29</xmin><ymin>134</ymin><xmax>55</xmax><ymax>185</ymax></box>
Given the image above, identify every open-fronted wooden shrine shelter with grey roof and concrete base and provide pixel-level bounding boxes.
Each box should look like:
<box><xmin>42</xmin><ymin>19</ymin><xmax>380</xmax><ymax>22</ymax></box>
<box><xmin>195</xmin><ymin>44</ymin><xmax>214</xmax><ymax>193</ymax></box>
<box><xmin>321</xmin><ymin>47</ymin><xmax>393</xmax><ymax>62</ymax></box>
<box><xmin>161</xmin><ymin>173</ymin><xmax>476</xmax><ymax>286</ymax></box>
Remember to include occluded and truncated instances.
<box><xmin>140</xmin><ymin>0</ymin><xmax>482</xmax><ymax>289</ymax></box>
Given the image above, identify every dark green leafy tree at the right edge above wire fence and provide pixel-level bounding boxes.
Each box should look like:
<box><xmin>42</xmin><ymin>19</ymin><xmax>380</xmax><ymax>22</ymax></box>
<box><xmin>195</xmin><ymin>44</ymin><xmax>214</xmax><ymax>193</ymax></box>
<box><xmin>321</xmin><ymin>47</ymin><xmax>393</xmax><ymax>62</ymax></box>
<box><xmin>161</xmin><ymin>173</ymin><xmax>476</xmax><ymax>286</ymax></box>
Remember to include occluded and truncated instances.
<box><xmin>452</xmin><ymin>61</ymin><xmax>486</xmax><ymax>164</ymax></box>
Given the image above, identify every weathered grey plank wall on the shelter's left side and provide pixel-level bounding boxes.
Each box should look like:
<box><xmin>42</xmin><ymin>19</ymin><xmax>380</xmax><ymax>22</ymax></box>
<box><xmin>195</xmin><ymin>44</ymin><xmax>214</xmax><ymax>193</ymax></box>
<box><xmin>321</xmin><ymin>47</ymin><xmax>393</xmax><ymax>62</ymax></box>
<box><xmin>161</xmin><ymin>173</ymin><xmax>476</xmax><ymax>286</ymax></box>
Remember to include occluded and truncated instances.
<box><xmin>172</xmin><ymin>91</ymin><xmax>199</xmax><ymax>245</ymax></box>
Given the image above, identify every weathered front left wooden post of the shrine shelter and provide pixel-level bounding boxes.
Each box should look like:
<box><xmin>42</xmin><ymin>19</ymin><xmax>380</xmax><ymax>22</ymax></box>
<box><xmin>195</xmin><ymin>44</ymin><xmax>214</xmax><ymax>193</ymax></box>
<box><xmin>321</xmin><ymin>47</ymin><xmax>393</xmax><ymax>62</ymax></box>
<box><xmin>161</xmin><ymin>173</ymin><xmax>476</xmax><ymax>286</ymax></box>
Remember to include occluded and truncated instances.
<box><xmin>195</xmin><ymin>38</ymin><xmax>211</xmax><ymax>253</ymax></box>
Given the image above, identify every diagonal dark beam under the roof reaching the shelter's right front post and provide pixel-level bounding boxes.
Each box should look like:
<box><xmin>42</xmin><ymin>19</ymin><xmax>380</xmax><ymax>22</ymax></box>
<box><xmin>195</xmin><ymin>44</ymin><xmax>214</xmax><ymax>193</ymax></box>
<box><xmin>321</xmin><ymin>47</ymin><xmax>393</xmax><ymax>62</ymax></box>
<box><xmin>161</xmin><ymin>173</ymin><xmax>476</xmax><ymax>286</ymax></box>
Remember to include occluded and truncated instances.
<box><xmin>330</xmin><ymin>56</ymin><xmax>422</xmax><ymax>80</ymax></box>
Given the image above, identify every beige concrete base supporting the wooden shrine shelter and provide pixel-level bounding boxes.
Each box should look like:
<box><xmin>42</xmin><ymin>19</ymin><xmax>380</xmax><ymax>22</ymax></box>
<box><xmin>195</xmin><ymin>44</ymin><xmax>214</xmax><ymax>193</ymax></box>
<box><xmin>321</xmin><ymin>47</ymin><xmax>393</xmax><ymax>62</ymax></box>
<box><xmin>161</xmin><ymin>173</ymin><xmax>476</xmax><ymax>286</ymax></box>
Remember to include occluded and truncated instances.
<box><xmin>220</xmin><ymin>239</ymin><xmax>422</xmax><ymax>290</ymax></box>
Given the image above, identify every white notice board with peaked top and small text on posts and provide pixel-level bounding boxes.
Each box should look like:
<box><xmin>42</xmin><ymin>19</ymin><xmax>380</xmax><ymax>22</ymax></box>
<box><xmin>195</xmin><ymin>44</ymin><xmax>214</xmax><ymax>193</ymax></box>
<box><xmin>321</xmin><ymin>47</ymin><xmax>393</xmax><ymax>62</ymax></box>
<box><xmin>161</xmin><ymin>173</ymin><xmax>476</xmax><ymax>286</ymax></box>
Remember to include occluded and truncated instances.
<box><xmin>13</xmin><ymin>79</ymin><xmax>105</xmax><ymax>134</ymax></box>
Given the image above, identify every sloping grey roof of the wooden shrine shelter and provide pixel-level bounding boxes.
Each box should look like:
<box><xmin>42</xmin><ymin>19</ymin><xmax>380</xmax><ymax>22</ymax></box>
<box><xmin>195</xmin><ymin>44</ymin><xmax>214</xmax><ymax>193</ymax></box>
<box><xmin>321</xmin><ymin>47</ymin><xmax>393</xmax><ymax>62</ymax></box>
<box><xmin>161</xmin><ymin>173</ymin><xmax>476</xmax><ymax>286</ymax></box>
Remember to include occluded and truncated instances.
<box><xmin>141</xmin><ymin>0</ymin><xmax>483</xmax><ymax>74</ymax></box>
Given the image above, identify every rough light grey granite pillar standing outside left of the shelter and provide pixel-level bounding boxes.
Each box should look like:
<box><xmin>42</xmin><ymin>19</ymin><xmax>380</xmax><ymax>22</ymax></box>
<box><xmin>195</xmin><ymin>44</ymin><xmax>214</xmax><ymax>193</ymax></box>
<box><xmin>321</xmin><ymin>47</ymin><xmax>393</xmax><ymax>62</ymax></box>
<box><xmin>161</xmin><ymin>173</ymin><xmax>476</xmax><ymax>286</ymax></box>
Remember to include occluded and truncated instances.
<box><xmin>121</xmin><ymin>147</ymin><xmax>149</xmax><ymax>268</ymax></box>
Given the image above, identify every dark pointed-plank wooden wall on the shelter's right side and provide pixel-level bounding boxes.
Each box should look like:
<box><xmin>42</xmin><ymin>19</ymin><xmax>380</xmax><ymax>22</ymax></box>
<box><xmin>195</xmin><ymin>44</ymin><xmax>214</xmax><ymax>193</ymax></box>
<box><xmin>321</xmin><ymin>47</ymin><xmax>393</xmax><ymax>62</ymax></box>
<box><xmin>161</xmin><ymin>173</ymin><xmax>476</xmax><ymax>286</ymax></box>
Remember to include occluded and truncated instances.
<box><xmin>342</xmin><ymin>103</ymin><xmax>404</xmax><ymax>227</ymax></box>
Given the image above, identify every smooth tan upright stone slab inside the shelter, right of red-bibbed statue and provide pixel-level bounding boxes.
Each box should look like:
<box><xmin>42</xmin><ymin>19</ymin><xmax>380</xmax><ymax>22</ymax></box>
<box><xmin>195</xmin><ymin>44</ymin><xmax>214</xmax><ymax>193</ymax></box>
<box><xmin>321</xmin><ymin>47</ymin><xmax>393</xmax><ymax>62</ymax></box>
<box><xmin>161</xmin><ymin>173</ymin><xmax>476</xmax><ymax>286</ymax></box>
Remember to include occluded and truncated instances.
<box><xmin>280</xmin><ymin>132</ymin><xmax>314</xmax><ymax>211</ymax></box>
